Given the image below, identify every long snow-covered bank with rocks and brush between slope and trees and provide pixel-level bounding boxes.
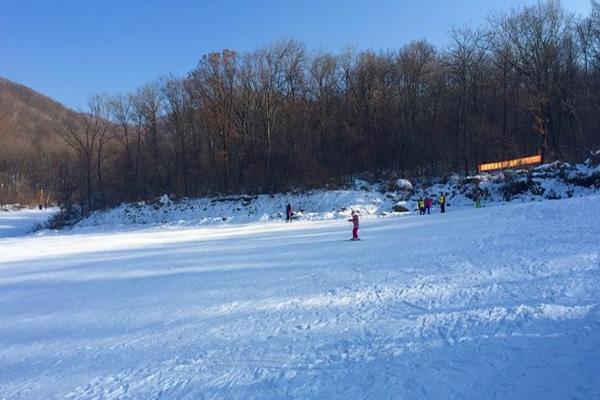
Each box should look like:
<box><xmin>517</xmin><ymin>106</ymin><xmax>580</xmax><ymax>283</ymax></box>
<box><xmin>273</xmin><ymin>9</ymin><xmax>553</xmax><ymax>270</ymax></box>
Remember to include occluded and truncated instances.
<box><xmin>71</xmin><ymin>151</ymin><xmax>600</xmax><ymax>229</ymax></box>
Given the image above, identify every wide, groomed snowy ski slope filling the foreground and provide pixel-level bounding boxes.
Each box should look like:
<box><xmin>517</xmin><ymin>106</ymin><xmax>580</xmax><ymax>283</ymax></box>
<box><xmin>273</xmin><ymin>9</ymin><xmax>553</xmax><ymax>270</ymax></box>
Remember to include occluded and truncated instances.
<box><xmin>0</xmin><ymin>195</ymin><xmax>600</xmax><ymax>400</ymax></box>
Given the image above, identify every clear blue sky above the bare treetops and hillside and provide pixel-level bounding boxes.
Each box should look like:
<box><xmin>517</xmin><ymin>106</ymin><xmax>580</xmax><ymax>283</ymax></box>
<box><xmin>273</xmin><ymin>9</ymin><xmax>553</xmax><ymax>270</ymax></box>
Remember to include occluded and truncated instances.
<box><xmin>0</xmin><ymin>0</ymin><xmax>590</xmax><ymax>109</ymax></box>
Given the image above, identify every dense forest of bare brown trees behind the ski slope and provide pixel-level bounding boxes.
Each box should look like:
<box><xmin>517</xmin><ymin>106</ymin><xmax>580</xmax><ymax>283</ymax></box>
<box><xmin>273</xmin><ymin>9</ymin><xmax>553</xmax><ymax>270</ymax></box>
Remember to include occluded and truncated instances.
<box><xmin>5</xmin><ymin>0</ymin><xmax>600</xmax><ymax>210</ymax></box>
